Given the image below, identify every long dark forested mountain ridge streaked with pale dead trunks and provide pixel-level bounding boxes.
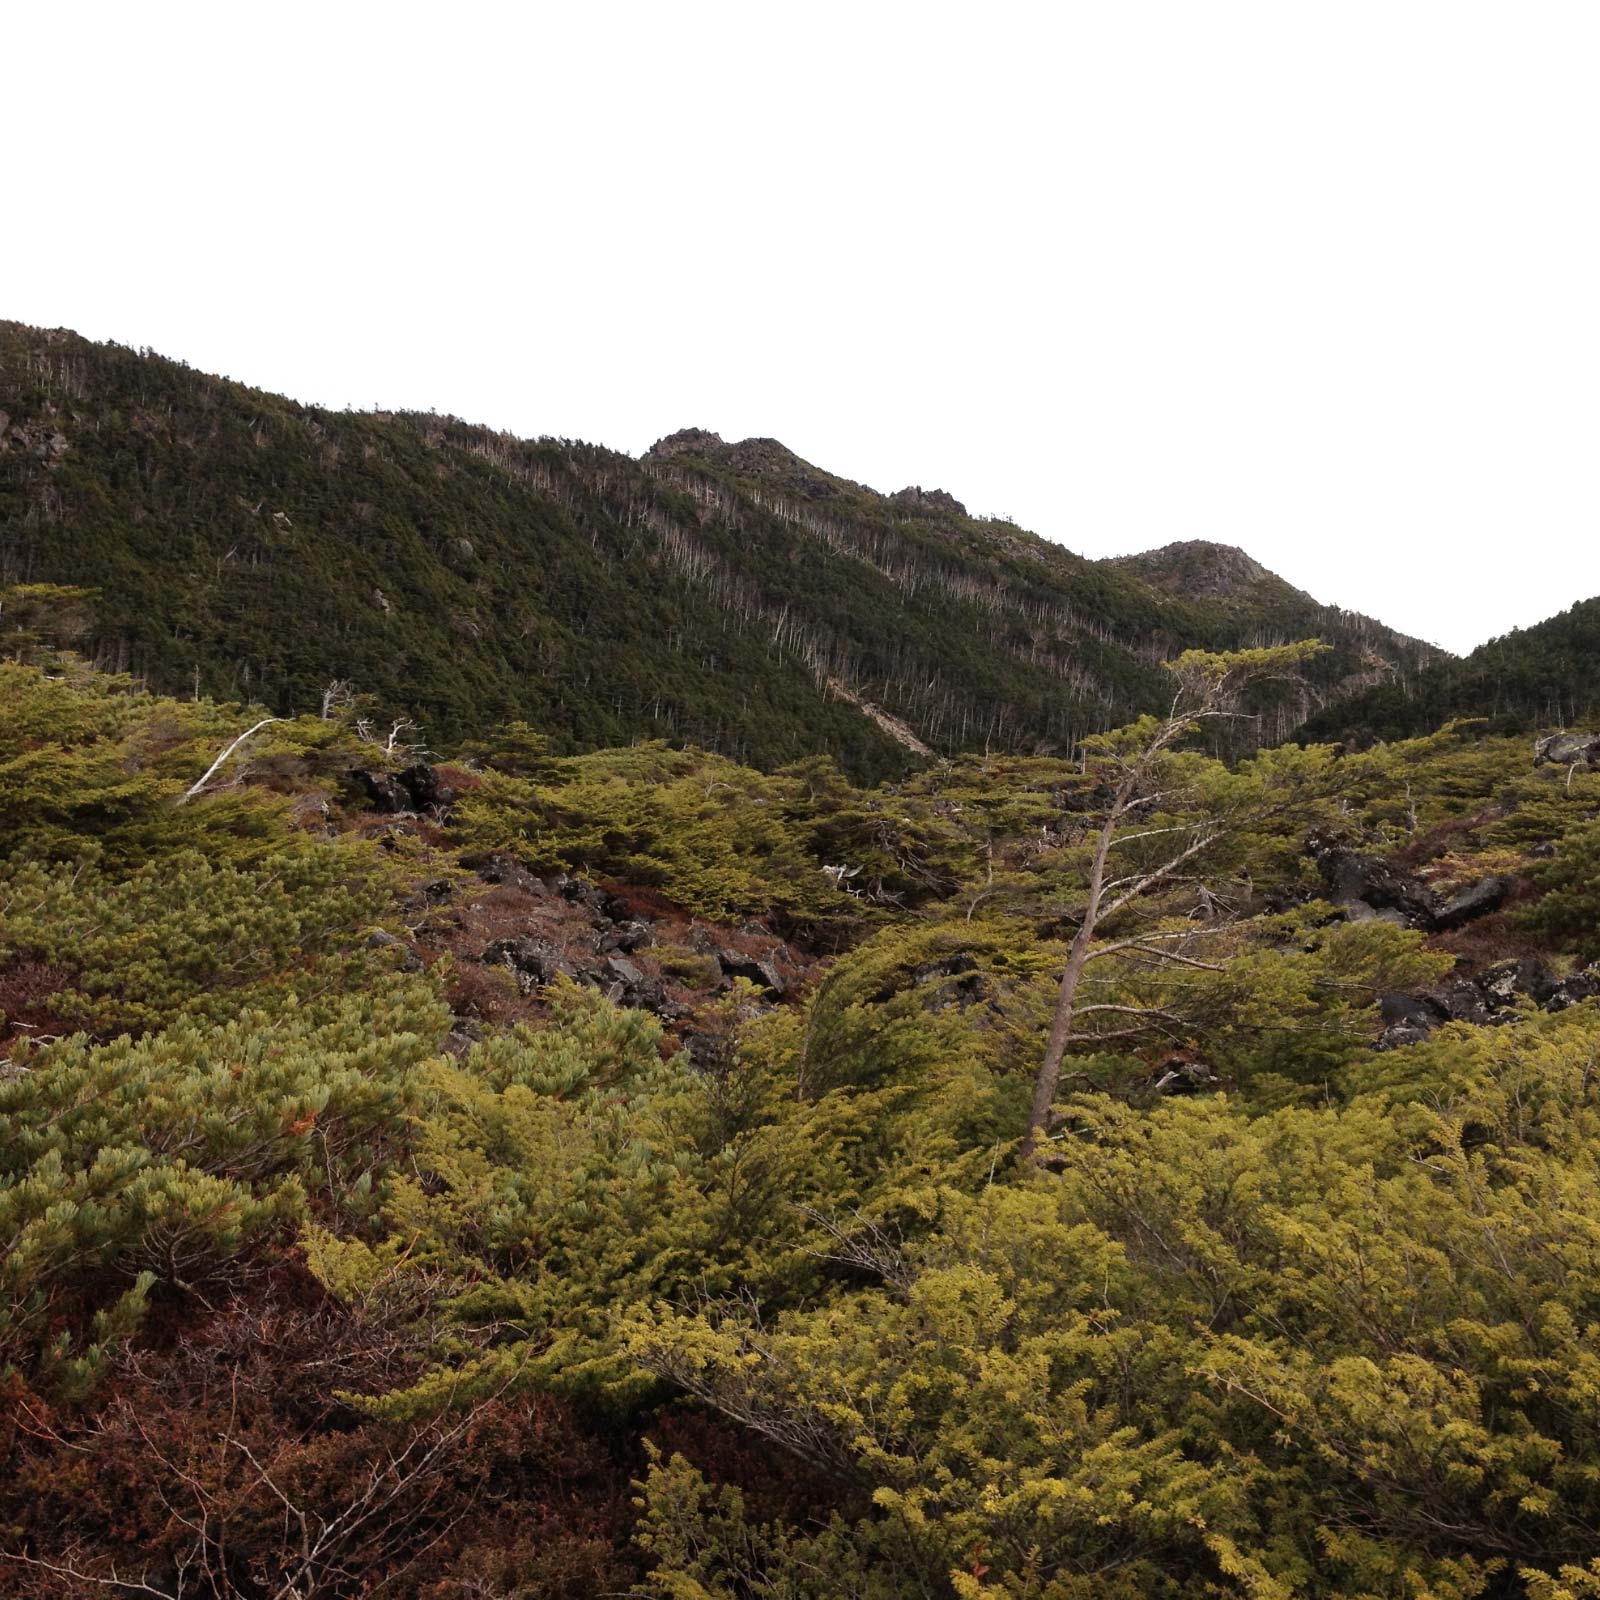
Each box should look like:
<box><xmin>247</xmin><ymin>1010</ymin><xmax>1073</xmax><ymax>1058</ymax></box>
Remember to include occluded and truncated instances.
<box><xmin>0</xmin><ymin>323</ymin><xmax>1437</xmax><ymax>779</ymax></box>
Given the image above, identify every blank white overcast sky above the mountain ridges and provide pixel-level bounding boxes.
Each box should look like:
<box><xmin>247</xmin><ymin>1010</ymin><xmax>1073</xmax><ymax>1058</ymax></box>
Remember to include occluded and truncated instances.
<box><xmin>0</xmin><ymin>0</ymin><xmax>1600</xmax><ymax>650</ymax></box>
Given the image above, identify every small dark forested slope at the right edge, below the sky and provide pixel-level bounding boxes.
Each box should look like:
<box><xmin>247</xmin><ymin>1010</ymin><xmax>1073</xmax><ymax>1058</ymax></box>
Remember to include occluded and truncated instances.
<box><xmin>1301</xmin><ymin>598</ymin><xmax>1600</xmax><ymax>744</ymax></box>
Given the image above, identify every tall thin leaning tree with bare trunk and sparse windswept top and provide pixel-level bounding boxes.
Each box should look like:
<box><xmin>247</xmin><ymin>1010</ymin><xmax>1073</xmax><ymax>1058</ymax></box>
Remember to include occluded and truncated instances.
<box><xmin>1021</xmin><ymin>642</ymin><xmax>1323</xmax><ymax>1160</ymax></box>
